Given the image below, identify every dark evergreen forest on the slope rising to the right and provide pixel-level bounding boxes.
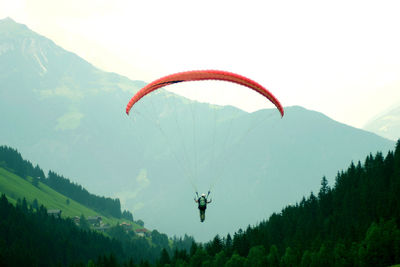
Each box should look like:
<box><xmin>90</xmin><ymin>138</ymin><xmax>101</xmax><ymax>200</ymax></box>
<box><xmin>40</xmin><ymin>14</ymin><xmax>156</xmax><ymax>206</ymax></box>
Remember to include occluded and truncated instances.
<box><xmin>162</xmin><ymin>140</ymin><xmax>400</xmax><ymax>266</ymax></box>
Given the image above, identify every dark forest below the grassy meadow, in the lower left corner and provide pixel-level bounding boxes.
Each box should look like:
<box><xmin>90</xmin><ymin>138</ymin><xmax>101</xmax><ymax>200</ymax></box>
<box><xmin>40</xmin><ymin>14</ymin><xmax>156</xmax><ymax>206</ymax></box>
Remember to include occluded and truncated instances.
<box><xmin>0</xmin><ymin>194</ymin><xmax>178</xmax><ymax>266</ymax></box>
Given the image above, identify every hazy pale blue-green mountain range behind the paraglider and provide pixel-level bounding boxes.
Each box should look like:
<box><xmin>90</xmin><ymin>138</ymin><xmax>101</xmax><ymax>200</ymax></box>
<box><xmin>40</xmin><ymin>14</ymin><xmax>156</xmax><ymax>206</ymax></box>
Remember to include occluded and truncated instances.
<box><xmin>0</xmin><ymin>18</ymin><xmax>394</xmax><ymax>241</ymax></box>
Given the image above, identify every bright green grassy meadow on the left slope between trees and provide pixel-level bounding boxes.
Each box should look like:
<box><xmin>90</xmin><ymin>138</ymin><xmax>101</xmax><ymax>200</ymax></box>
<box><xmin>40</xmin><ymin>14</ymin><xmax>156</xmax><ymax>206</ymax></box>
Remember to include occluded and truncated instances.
<box><xmin>0</xmin><ymin>167</ymin><xmax>141</xmax><ymax>229</ymax></box>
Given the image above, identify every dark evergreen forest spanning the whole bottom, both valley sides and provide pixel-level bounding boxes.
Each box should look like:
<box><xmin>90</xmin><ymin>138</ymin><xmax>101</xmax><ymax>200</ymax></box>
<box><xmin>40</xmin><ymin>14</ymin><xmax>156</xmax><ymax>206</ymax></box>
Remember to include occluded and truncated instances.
<box><xmin>0</xmin><ymin>140</ymin><xmax>400</xmax><ymax>267</ymax></box>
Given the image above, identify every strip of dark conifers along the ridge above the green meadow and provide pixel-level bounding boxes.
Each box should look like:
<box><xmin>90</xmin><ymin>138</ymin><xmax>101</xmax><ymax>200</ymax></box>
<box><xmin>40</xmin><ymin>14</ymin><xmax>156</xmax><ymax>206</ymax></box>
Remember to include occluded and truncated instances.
<box><xmin>0</xmin><ymin>146</ymin><xmax>133</xmax><ymax>221</ymax></box>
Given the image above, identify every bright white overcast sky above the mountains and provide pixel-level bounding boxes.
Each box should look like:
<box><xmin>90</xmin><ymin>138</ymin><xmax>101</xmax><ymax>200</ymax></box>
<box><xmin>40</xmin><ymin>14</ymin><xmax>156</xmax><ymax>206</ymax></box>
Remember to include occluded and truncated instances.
<box><xmin>0</xmin><ymin>0</ymin><xmax>400</xmax><ymax>127</ymax></box>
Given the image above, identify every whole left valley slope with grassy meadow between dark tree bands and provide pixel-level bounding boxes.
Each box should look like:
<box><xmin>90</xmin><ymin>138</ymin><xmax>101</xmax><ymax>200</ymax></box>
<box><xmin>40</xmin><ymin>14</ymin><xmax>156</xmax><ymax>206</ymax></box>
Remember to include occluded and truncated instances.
<box><xmin>0</xmin><ymin>146</ymin><xmax>194</xmax><ymax>266</ymax></box>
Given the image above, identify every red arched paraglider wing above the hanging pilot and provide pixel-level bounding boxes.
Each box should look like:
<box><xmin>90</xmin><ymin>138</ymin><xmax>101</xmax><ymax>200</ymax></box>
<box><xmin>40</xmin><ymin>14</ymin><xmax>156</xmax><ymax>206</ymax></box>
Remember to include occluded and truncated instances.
<box><xmin>126</xmin><ymin>70</ymin><xmax>284</xmax><ymax>117</ymax></box>
